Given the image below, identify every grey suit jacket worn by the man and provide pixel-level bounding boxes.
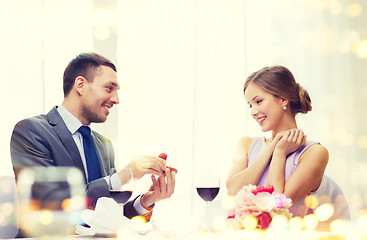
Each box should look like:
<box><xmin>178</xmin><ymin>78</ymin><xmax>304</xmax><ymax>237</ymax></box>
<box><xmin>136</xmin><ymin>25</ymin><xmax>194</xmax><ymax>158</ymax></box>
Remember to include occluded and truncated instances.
<box><xmin>10</xmin><ymin>106</ymin><xmax>138</xmax><ymax>218</ymax></box>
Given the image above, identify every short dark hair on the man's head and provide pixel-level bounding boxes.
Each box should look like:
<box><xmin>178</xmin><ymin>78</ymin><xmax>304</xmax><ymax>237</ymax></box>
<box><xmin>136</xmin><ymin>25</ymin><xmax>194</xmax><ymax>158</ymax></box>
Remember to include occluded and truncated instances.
<box><xmin>63</xmin><ymin>52</ymin><xmax>117</xmax><ymax>97</ymax></box>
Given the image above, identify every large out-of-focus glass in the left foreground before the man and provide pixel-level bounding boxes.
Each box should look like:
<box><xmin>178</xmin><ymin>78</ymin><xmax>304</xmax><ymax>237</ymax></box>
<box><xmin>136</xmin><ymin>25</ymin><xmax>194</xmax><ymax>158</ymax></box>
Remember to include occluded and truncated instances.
<box><xmin>17</xmin><ymin>167</ymin><xmax>86</xmax><ymax>239</ymax></box>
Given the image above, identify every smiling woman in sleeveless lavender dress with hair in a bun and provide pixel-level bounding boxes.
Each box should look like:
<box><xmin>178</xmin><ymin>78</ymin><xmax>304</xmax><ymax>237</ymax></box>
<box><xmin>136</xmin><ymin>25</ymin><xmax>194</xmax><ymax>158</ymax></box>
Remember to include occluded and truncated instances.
<box><xmin>227</xmin><ymin>66</ymin><xmax>349</xmax><ymax>223</ymax></box>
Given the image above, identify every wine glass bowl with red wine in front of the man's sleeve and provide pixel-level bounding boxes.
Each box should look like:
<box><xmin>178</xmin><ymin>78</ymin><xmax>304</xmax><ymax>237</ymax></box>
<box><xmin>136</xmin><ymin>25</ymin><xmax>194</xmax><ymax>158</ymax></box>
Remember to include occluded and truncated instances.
<box><xmin>109</xmin><ymin>168</ymin><xmax>134</xmax><ymax>205</ymax></box>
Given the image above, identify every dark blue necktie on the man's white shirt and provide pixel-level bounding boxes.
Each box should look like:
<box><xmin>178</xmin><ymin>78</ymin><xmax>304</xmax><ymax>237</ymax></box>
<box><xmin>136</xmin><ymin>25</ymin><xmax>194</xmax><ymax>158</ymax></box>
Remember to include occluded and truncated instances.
<box><xmin>79</xmin><ymin>126</ymin><xmax>102</xmax><ymax>182</ymax></box>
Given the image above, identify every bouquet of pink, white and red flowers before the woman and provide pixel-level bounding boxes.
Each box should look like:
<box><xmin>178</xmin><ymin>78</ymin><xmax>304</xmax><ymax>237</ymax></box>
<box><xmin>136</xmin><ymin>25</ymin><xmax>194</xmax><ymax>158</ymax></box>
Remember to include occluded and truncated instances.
<box><xmin>227</xmin><ymin>185</ymin><xmax>292</xmax><ymax>229</ymax></box>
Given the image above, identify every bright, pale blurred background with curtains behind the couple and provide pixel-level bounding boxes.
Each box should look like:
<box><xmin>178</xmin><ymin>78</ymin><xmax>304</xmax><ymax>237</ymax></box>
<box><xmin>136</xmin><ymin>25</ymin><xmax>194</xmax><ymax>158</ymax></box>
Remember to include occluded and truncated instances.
<box><xmin>0</xmin><ymin>0</ymin><xmax>367</xmax><ymax>225</ymax></box>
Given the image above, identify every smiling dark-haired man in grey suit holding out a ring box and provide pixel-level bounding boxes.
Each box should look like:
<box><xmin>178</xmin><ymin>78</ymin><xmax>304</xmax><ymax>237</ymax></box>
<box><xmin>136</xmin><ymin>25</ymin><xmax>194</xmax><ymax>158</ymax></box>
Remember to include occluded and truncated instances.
<box><xmin>10</xmin><ymin>53</ymin><xmax>176</xmax><ymax>221</ymax></box>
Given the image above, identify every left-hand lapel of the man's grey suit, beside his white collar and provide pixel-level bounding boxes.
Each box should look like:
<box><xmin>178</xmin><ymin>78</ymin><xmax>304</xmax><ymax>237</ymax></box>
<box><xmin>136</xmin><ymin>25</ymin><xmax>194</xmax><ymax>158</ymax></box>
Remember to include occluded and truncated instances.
<box><xmin>47</xmin><ymin>107</ymin><xmax>86</xmax><ymax>179</ymax></box>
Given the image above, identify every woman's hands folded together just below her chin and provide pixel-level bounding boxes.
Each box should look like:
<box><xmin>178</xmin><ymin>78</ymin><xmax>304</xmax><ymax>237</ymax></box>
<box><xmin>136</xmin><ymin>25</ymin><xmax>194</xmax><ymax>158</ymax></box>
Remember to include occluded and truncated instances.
<box><xmin>273</xmin><ymin>128</ymin><xmax>307</xmax><ymax>156</ymax></box>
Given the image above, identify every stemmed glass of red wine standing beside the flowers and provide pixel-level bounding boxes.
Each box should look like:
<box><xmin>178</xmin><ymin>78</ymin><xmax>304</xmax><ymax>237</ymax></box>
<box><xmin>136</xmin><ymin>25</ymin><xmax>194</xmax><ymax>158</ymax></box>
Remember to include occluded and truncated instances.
<box><xmin>195</xmin><ymin>167</ymin><xmax>220</xmax><ymax>231</ymax></box>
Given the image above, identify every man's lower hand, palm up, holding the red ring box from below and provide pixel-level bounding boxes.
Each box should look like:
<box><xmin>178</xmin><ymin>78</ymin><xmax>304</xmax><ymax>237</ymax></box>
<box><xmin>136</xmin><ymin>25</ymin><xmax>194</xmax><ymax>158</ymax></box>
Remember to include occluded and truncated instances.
<box><xmin>141</xmin><ymin>168</ymin><xmax>176</xmax><ymax>209</ymax></box>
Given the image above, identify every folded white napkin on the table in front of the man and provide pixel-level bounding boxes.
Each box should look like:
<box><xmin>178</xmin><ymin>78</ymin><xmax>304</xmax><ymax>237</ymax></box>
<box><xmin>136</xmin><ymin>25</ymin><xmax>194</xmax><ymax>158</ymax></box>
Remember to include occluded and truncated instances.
<box><xmin>76</xmin><ymin>197</ymin><xmax>128</xmax><ymax>235</ymax></box>
